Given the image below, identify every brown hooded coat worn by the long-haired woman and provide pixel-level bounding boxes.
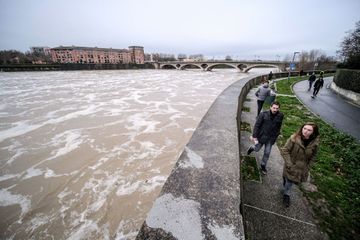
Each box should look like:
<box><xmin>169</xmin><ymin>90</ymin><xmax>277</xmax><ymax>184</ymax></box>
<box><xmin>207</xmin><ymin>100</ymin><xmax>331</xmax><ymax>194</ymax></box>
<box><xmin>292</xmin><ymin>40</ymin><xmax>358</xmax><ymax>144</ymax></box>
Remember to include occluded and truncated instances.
<box><xmin>281</xmin><ymin>134</ymin><xmax>320</xmax><ymax>183</ymax></box>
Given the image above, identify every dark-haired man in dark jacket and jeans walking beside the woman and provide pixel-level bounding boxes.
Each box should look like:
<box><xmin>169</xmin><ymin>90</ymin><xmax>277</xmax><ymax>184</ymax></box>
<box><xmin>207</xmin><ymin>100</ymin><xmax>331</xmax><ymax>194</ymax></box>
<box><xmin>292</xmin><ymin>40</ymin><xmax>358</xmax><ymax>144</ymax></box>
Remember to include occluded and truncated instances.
<box><xmin>247</xmin><ymin>101</ymin><xmax>284</xmax><ymax>175</ymax></box>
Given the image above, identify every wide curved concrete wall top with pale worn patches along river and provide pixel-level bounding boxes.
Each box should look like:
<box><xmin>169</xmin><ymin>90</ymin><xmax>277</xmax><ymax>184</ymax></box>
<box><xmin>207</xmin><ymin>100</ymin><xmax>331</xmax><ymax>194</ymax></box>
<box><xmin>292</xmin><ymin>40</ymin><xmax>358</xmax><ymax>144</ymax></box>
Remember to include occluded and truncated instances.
<box><xmin>136</xmin><ymin>73</ymin><xmax>288</xmax><ymax>240</ymax></box>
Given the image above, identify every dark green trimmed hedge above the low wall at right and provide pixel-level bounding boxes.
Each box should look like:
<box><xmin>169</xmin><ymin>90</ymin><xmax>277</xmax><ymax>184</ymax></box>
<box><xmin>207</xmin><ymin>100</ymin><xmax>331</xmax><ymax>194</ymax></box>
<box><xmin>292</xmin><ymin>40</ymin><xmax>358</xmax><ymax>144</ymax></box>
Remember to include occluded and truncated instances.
<box><xmin>334</xmin><ymin>69</ymin><xmax>360</xmax><ymax>93</ymax></box>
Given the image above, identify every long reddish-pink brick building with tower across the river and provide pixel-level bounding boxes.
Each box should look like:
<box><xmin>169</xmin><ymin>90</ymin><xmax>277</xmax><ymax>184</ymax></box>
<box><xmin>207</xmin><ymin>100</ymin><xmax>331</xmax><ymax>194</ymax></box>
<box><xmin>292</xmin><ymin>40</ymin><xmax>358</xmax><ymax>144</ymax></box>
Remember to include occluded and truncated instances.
<box><xmin>50</xmin><ymin>46</ymin><xmax>145</xmax><ymax>64</ymax></box>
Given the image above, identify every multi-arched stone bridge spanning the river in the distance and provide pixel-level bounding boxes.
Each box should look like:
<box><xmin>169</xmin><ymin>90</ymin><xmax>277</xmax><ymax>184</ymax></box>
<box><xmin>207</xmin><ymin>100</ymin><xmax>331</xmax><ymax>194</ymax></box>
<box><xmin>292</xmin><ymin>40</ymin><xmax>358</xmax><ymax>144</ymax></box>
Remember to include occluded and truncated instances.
<box><xmin>152</xmin><ymin>61</ymin><xmax>289</xmax><ymax>72</ymax></box>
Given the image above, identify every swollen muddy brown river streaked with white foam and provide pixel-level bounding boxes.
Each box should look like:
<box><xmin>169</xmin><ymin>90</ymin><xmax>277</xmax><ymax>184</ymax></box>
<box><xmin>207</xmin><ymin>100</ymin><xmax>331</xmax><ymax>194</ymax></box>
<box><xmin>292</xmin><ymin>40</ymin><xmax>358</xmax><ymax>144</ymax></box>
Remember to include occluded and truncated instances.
<box><xmin>0</xmin><ymin>69</ymin><xmax>276</xmax><ymax>240</ymax></box>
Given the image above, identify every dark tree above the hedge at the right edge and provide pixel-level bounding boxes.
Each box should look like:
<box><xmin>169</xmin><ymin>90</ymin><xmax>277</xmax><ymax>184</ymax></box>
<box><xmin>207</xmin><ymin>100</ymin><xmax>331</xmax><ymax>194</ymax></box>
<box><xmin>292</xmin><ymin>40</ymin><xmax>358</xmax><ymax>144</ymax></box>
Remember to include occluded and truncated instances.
<box><xmin>338</xmin><ymin>21</ymin><xmax>360</xmax><ymax>69</ymax></box>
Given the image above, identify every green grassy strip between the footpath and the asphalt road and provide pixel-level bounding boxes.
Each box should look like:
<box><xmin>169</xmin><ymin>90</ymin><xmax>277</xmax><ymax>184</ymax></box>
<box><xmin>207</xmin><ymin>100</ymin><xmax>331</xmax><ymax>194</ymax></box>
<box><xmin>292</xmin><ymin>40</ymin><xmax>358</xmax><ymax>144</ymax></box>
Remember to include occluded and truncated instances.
<box><xmin>276</xmin><ymin>77</ymin><xmax>360</xmax><ymax>240</ymax></box>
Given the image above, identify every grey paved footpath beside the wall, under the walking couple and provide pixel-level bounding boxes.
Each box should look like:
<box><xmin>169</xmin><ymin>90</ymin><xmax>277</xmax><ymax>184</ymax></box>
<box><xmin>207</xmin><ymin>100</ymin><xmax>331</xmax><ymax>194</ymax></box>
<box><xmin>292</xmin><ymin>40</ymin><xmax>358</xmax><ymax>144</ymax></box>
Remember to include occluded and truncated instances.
<box><xmin>240</xmin><ymin>88</ymin><xmax>328</xmax><ymax>240</ymax></box>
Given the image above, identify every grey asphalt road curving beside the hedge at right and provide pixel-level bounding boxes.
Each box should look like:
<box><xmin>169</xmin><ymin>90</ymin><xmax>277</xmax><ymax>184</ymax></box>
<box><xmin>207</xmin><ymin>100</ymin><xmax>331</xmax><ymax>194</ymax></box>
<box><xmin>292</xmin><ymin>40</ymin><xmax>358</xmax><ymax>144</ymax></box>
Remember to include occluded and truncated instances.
<box><xmin>293</xmin><ymin>77</ymin><xmax>360</xmax><ymax>141</ymax></box>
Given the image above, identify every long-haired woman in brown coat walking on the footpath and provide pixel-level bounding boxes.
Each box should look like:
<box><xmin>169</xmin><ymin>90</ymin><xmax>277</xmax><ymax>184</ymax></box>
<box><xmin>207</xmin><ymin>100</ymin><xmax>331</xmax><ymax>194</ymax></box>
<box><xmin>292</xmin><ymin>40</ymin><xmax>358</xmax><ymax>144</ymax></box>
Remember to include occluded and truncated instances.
<box><xmin>281</xmin><ymin>122</ymin><xmax>320</xmax><ymax>207</ymax></box>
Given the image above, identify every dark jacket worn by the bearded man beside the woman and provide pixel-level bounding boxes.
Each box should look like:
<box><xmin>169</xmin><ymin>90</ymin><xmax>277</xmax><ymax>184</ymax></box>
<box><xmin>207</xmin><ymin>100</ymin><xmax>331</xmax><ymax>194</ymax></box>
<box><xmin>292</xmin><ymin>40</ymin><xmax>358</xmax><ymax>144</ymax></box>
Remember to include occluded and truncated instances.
<box><xmin>253</xmin><ymin>110</ymin><xmax>284</xmax><ymax>144</ymax></box>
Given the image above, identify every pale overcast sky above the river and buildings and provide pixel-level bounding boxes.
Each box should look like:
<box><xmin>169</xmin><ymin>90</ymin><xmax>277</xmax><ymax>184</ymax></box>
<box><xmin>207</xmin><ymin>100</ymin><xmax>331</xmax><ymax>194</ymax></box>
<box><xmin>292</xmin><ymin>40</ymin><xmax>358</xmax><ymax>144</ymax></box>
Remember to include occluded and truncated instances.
<box><xmin>0</xmin><ymin>0</ymin><xmax>360</xmax><ymax>59</ymax></box>
